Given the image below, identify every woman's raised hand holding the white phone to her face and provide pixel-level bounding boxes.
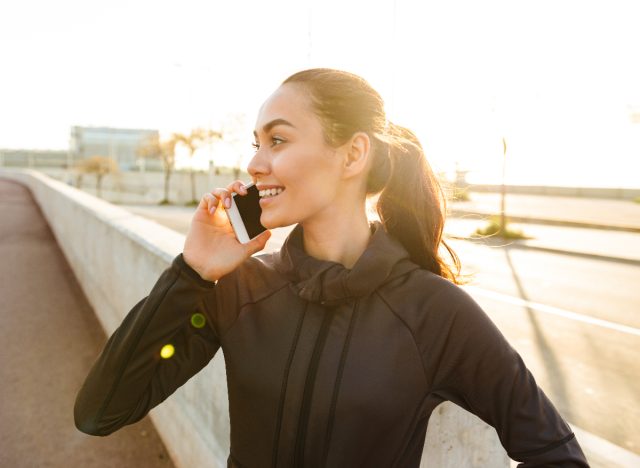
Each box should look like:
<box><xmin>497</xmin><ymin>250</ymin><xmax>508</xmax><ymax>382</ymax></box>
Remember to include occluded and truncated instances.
<box><xmin>182</xmin><ymin>180</ymin><xmax>271</xmax><ymax>281</ymax></box>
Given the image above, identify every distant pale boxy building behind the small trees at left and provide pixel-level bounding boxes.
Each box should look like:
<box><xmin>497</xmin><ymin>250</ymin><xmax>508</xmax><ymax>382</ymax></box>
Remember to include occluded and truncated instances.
<box><xmin>69</xmin><ymin>126</ymin><xmax>162</xmax><ymax>171</ymax></box>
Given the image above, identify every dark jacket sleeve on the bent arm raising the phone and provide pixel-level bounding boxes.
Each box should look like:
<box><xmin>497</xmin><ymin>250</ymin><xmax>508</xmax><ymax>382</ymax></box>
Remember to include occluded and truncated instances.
<box><xmin>74</xmin><ymin>253</ymin><xmax>220</xmax><ymax>436</ymax></box>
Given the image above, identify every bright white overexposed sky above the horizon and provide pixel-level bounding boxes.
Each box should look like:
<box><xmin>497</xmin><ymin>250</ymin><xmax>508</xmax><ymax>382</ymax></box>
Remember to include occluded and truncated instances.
<box><xmin>0</xmin><ymin>0</ymin><xmax>640</xmax><ymax>188</ymax></box>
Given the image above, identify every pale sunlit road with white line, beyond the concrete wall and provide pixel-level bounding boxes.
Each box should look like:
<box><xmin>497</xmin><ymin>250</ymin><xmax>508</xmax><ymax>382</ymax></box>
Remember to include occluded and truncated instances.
<box><xmin>123</xmin><ymin>206</ymin><xmax>640</xmax><ymax>453</ymax></box>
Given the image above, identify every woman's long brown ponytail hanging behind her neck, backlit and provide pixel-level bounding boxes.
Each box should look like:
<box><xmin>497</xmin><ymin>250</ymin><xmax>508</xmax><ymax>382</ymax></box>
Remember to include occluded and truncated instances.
<box><xmin>368</xmin><ymin>122</ymin><xmax>461</xmax><ymax>284</ymax></box>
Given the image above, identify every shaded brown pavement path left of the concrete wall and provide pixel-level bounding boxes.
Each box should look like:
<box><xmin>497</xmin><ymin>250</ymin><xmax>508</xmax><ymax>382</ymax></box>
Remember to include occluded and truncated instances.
<box><xmin>0</xmin><ymin>178</ymin><xmax>173</xmax><ymax>468</ymax></box>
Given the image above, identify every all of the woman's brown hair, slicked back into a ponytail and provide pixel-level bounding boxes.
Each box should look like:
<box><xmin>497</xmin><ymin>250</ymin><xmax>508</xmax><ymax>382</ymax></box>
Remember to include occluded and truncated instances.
<box><xmin>283</xmin><ymin>68</ymin><xmax>462</xmax><ymax>284</ymax></box>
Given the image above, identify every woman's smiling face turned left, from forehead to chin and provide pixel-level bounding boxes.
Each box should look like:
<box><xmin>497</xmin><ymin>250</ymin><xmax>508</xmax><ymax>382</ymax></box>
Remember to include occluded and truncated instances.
<box><xmin>248</xmin><ymin>84</ymin><xmax>342</xmax><ymax>229</ymax></box>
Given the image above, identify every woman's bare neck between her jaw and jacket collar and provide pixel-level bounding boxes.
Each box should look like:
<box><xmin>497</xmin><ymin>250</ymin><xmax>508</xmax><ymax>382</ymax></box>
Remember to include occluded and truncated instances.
<box><xmin>302</xmin><ymin>206</ymin><xmax>371</xmax><ymax>268</ymax></box>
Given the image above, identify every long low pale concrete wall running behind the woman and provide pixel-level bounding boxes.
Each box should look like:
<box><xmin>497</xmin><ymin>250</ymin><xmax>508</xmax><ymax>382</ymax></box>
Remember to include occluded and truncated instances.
<box><xmin>0</xmin><ymin>169</ymin><xmax>509</xmax><ymax>468</ymax></box>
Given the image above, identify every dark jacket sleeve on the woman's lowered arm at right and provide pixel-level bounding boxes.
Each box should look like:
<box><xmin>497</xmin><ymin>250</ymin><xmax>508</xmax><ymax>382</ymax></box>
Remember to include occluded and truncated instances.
<box><xmin>425</xmin><ymin>288</ymin><xmax>589</xmax><ymax>468</ymax></box>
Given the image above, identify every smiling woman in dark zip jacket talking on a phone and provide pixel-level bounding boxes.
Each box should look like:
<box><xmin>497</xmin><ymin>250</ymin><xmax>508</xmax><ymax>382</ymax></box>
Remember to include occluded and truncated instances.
<box><xmin>75</xmin><ymin>69</ymin><xmax>588</xmax><ymax>467</ymax></box>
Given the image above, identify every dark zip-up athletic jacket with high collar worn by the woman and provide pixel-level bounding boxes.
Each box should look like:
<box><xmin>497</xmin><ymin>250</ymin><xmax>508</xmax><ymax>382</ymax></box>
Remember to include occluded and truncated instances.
<box><xmin>75</xmin><ymin>223</ymin><xmax>588</xmax><ymax>468</ymax></box>
